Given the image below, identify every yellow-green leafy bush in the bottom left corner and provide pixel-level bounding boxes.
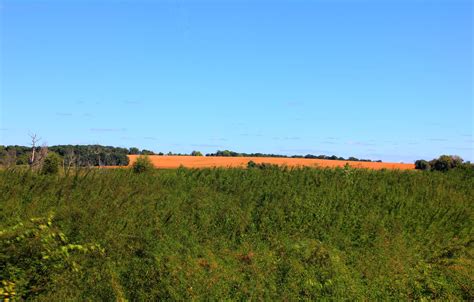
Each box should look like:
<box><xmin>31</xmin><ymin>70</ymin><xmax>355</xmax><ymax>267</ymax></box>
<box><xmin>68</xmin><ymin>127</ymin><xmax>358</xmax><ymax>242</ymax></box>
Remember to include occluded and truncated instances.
<box><xmin>0</xmin><ymin>215</ymin><xmax>105</xmax><ymax>300</ymax></box>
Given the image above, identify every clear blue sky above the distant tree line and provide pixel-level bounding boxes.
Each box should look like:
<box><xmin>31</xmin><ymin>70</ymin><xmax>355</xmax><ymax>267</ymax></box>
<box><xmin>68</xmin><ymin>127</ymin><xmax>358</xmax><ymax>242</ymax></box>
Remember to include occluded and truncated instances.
<box><xmin>0</xmin><ymin>0</ymin><xmax>474</xmax><ymax>162</ymax></box>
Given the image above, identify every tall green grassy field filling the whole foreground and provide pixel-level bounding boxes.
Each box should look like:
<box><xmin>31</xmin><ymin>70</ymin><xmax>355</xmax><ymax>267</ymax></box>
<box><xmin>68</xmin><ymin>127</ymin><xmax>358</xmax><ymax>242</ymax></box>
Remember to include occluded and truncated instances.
<box><xmin>0</xmin><ymin>168</ymin><xmax>474</xmax><ymax>301</ymax></box>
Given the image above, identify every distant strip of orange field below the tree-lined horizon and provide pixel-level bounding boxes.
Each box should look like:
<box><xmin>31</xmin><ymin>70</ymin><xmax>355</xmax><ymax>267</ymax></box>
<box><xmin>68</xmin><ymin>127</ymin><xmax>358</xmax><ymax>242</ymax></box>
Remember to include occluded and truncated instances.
<box><xmin>129</xmin><ymin>155</ymin><xmax>415</xmax><ymax>170</ymax></box>
